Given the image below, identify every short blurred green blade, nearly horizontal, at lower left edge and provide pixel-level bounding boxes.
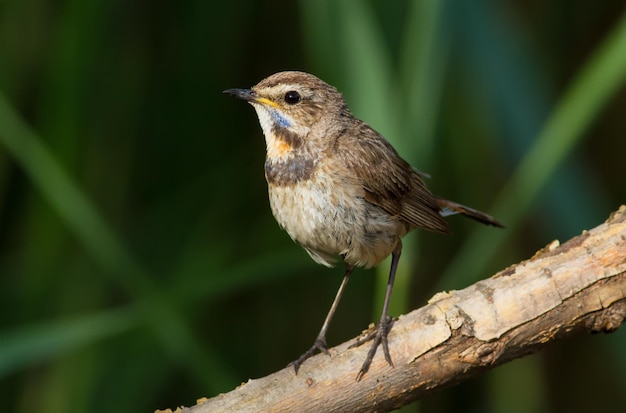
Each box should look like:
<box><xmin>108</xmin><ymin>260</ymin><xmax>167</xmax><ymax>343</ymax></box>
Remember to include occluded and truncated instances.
<box><xmin>0</xmin><ymin>308</ymin><xmax>138</xmax><ymax>378</ymax></box>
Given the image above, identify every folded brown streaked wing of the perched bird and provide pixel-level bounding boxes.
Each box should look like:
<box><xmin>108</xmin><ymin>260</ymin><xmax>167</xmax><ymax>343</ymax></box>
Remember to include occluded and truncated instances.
<box><xmin>335</xmin><ymin>122</ymin><xmax>449</xmax><ymax>233</ymax></box>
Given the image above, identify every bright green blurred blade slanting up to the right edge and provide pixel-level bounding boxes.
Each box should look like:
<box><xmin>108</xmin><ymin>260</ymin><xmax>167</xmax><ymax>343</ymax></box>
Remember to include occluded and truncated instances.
<box><xmin>439</xmin><ymin>8</ymin><xmax>626</xmax><ymax>288</ymax></box>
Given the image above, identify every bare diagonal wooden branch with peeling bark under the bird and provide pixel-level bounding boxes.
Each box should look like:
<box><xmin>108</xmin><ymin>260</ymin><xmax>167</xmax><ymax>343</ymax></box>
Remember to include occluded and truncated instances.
<box><xmin>162</xmin><ymin>206</ymin><xmax>626</xmax><ymax>413</ymax></box>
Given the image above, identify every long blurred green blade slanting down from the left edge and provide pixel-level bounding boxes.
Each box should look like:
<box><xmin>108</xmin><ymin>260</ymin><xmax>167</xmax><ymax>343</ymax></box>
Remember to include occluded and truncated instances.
<box><xmin>0</xmin><ymin>94</ymin><xmax>236</xmax><ymax>390</ymax></box>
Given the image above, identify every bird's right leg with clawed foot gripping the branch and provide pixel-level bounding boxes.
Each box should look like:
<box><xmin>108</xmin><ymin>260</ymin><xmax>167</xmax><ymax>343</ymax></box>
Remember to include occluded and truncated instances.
<box><xmin>350</xmin><ymin>244</ymin><xmax>402</xmax><ymax>381</ymax></box>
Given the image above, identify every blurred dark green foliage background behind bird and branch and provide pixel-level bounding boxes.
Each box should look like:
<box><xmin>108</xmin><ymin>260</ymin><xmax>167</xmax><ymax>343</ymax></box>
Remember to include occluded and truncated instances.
<box><xmin>0</xmin><ymin>0</ymin><xmax>626</xmax><ymax>412</ymax></box>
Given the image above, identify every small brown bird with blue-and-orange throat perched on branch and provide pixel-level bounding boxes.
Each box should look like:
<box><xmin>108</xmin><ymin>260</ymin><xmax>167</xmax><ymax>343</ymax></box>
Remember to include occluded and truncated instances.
<box><xmin>223</xmin><ymin>71</ymin><xmax>503</xmax><ymax>381</ymax></box>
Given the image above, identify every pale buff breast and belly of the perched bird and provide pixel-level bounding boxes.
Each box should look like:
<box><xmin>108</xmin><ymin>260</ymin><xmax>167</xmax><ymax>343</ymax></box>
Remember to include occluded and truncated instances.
<box><xmin>265</xmin><ymin>159</ymin><xmax>406</xmax><ymax>267</ymax></box>
